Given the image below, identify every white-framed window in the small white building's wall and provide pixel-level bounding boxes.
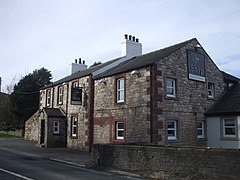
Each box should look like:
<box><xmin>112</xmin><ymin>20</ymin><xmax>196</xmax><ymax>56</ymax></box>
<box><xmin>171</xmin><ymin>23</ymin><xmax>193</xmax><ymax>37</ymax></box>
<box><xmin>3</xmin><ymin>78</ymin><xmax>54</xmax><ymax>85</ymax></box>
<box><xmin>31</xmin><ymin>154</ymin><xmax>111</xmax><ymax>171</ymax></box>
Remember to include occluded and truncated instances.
<box><xmin>223</xmin><ymin>118</ymin><xmax>237</xmax><ymax>138</ymax></box>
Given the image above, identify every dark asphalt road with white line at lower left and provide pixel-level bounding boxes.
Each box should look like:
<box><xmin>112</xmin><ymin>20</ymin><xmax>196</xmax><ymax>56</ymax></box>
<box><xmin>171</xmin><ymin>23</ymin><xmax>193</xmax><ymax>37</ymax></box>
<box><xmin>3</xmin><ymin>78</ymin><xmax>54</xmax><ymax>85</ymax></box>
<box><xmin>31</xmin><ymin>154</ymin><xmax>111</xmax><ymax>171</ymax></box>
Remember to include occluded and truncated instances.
<box><xmin>0</xmin><ymin>147</ymin><xmax>138</xmax><ymax>180</ymax></box>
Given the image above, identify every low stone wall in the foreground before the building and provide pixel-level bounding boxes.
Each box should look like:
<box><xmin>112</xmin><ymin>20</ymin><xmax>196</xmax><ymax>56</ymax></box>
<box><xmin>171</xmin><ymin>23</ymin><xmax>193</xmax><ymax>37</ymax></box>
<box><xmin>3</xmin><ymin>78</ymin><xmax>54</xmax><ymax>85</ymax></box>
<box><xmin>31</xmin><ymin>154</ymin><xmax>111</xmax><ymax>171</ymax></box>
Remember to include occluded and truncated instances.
<box><xmin>92</xmin><ymin>144</ymin><xmax>240</xmax><ymax>179</ymax></box>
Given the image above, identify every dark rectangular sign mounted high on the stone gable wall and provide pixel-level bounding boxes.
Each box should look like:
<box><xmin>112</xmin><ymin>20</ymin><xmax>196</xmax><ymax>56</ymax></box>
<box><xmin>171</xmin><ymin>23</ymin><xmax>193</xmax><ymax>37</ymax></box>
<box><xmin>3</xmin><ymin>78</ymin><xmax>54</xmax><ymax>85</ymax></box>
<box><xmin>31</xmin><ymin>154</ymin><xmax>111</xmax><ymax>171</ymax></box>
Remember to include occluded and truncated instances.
<box><xmin>187</xmin><ymin>50</ymin><xmax>206</xmax><ymax>82</ymax></box>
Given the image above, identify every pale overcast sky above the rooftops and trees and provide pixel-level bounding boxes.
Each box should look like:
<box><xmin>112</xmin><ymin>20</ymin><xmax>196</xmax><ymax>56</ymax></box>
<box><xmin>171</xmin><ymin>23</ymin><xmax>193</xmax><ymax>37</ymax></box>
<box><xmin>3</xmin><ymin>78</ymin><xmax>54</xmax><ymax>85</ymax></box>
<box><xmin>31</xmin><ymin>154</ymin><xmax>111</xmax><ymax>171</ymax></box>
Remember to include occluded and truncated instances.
<box><xmin>0</xmin><ymin>0</ymin><xmax>240</xmax><ymax>91</ymax></box>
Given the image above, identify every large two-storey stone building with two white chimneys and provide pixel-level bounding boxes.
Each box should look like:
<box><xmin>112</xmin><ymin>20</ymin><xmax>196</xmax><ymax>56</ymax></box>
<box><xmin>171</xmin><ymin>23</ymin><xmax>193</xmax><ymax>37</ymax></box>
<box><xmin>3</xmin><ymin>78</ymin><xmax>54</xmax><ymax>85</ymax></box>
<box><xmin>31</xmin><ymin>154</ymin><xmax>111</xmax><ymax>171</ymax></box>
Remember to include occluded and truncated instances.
<box><xmin>25</xmin><ymin>35</ymin><xmax>239</xmax><ymax>151</ymax></box>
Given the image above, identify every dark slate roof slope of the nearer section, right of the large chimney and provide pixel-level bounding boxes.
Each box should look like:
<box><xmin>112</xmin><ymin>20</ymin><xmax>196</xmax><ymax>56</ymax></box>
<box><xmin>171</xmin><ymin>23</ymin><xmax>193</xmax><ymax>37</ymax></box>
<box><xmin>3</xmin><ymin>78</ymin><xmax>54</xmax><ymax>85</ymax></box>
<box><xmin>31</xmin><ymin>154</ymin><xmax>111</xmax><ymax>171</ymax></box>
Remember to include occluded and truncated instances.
<box><xmin>94</xmin><ymin>38</ymin><xmax>197</xmax><ymax>79</ymax></box>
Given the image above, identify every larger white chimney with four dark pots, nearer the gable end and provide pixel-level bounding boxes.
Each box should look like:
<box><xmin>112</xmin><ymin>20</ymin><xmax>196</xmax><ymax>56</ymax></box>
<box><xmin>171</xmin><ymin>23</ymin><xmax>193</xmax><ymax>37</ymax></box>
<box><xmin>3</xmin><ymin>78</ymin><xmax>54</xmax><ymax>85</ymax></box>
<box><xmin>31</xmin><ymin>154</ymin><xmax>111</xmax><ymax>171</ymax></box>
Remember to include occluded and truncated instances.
<box><xmin>121</xmin><ymin>34</ymin><xmax>142</xmax><ymax>59</ymax></box>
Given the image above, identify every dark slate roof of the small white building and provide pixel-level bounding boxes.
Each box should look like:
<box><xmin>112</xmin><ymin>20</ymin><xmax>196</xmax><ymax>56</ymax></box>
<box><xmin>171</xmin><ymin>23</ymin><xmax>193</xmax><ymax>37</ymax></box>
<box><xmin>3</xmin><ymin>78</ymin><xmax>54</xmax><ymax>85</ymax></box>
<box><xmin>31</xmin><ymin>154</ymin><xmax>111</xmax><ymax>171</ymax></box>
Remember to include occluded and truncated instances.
<box><xmin>205</xmin><ymin>83</ymin><xmax>240</xmax><ymax>116</ymax></box>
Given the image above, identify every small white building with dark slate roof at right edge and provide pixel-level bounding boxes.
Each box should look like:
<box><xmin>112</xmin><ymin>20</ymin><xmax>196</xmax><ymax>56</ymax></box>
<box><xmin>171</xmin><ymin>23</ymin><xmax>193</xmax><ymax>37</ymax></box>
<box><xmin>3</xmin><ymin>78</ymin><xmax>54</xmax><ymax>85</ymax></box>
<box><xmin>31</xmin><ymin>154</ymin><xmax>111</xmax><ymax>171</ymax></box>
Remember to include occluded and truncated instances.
<box><xmin>206</xmin><ymin>83</ymin><xmax>240</xmax><ymax>149</ymax></box>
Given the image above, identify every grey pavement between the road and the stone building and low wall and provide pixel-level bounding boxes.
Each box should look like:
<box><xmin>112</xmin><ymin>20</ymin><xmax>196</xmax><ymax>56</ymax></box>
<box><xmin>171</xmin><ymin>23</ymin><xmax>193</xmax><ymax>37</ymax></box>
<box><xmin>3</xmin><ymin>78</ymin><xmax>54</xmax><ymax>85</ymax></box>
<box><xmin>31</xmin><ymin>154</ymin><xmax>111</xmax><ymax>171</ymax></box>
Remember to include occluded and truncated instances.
<box><xmin>0</xmin><ymin>137</ymin><xmax>142</xmax><ymax>179</ymax></box>
